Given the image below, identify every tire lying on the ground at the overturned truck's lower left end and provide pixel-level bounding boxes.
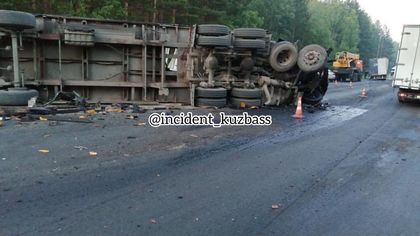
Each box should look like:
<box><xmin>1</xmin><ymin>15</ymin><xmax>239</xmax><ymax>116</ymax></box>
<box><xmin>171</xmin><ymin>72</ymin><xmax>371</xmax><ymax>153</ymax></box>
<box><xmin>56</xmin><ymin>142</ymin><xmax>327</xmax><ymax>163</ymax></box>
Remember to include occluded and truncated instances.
<box><xmin>0</xmin><ymin>88</ymin><xmax>39</xmax><ymax>106</ymax></box>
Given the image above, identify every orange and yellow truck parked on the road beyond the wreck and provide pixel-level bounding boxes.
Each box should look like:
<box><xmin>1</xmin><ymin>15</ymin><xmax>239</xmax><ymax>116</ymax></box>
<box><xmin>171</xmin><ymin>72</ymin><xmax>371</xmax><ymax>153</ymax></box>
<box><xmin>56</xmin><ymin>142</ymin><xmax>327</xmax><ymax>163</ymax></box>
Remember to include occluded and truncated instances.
<box><xmin>333</xmin><ymin>52</ymin><xmax>363</xmax><ymax>82</ymax></box>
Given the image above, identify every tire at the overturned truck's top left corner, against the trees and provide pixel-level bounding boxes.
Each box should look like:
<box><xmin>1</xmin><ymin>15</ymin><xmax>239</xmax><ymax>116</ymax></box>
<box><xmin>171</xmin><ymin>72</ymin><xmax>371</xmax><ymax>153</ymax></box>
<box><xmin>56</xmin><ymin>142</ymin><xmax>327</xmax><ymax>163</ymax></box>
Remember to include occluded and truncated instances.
<box><xmin>0</xmin><ymin>10</ymin><xmax>36</xmax><ymax>31</ymax></box>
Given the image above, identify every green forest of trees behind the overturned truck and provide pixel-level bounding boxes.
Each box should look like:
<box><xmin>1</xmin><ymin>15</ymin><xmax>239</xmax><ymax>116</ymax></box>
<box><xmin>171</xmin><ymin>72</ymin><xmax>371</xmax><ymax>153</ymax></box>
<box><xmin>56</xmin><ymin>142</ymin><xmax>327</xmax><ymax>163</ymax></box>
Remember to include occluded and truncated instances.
<box><xmin>0</xmin><ymin>0</ymin><xmax>398</xmax><ymax>66</ymax></box>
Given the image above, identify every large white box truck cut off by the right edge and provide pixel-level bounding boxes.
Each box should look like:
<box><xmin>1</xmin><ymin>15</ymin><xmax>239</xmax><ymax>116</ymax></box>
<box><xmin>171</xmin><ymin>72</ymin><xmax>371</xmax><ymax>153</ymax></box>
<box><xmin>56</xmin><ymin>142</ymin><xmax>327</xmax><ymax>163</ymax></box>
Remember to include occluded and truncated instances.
<box><xmin>392</xmin><ymin>25</ymin><xmax>420</xmax><ymax>102</ymax></box>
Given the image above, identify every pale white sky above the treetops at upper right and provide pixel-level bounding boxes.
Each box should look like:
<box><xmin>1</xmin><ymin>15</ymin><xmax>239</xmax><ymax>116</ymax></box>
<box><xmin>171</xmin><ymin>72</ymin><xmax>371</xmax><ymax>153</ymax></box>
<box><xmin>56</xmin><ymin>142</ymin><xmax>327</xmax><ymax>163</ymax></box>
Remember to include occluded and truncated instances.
<box><xmin>358</xmin><ymin>0</ymin><xmax>420</xmax><ymax>42</ymax></box>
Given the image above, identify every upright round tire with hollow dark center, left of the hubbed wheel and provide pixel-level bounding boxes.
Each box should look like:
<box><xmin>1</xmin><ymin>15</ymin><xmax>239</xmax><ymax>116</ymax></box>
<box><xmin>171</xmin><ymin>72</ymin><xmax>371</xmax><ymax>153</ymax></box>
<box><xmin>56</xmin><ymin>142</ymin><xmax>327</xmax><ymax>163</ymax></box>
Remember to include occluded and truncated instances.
<box><xmin>269</xmin><ymin>41</ymin><xmax>299</xmax><ymax>72</ymax></box>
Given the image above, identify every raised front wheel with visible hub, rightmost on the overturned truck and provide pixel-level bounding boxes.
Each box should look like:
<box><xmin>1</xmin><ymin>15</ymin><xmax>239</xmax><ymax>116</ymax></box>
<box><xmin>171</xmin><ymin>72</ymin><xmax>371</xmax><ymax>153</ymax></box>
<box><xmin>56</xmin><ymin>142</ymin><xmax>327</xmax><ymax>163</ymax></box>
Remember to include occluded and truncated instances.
<box><xmin>297</xmin><ymin>44</ymin><xmax>327</xmax><ymax>72</ymax></box>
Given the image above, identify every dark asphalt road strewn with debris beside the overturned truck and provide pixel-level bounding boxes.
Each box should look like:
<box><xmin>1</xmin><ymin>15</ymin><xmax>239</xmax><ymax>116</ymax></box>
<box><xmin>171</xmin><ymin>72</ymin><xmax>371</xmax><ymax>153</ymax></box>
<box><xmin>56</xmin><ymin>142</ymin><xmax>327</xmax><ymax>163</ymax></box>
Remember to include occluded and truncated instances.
<box><xmin>0</xmin><ymin>81</ymin><xmax>420</xmax><ymax>236</ymax></box>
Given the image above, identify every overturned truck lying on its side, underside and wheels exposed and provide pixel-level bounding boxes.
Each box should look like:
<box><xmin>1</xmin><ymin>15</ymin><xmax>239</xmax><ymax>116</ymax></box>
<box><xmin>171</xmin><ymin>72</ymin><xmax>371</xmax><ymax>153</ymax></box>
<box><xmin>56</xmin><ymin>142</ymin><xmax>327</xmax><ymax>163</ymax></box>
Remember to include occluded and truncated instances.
<box><xmin>0</xmin><ymin>10</ymin><xmax>329</xmax><ymax>107</ymax></box>
